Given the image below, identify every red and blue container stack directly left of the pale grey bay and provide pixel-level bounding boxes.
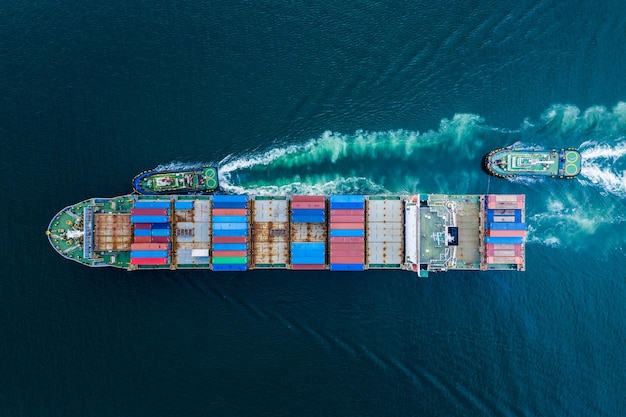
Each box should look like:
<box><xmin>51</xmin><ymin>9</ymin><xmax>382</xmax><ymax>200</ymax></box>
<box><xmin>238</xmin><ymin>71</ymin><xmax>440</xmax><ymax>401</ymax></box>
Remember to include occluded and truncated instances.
<box><xmin>330</xmin><ymin>195</ymin><xmax>365</xmax><ymax>271</ymax></box>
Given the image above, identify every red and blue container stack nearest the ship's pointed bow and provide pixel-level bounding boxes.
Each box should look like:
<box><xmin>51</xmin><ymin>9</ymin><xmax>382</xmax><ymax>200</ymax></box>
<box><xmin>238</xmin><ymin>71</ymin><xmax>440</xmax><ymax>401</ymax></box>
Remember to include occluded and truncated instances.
<box><xmin>130</xmin><ymin>200</ymin><xmax>171</xmax><ymax>266</ymax></box>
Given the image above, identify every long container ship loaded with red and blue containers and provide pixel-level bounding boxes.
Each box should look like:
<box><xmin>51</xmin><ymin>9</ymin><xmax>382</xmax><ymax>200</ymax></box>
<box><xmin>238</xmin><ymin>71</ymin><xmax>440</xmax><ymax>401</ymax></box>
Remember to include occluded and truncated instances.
<box><xmin>46</xmin><ymin>193</ymin><xmax>527</xmax><ymax>277</ymax></box>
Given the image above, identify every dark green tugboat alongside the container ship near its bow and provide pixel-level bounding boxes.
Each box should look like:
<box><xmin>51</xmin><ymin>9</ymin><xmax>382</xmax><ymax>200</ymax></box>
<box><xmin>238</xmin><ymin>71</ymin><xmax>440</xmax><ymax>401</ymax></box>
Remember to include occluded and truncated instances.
<box><xmin>133</xmin><ymin>165</ymin><xmax>219</xmax><ymax>195</ymax></box>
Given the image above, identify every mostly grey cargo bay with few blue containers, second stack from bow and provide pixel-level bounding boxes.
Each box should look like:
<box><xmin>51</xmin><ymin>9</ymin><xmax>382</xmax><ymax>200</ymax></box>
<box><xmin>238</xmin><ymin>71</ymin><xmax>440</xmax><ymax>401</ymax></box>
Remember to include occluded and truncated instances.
<box><xmin>174</xmin><ymin>200</ymin><xmax>211</xmax><ymax>268</ymax></box>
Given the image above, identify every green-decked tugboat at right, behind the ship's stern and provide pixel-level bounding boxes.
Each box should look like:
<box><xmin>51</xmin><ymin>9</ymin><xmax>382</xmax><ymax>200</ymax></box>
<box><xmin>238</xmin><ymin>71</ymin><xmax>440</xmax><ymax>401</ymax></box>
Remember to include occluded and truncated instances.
<box><xmin>483</xmin><ymin>147</ymin><xmax>581</xmax><ymax>179</ymax></box>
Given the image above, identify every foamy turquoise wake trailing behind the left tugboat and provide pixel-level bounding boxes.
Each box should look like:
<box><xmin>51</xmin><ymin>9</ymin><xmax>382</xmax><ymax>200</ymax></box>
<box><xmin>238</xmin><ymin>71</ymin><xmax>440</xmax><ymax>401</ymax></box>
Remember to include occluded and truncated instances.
<box><xmin>219</xmin><ymin>114</ymin><xmax>490</xmax><ymax>194</ymax></box>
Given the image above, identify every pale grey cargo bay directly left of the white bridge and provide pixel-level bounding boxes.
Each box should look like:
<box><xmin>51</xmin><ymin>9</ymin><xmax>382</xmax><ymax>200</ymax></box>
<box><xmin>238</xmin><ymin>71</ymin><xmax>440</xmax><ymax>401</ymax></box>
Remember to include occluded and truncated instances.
<box><xmin>366</xmin><ymin>196</ymin><xmax>404</xmax><ymax>269</ymax></box>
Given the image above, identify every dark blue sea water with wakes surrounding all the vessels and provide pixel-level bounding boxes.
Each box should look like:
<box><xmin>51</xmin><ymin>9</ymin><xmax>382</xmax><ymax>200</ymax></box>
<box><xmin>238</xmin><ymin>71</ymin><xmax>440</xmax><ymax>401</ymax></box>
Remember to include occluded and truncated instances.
<box><xmin>0</xmin><ymin>0</ymin><xmax>626</xmax><ymax>417</ymax></box>
